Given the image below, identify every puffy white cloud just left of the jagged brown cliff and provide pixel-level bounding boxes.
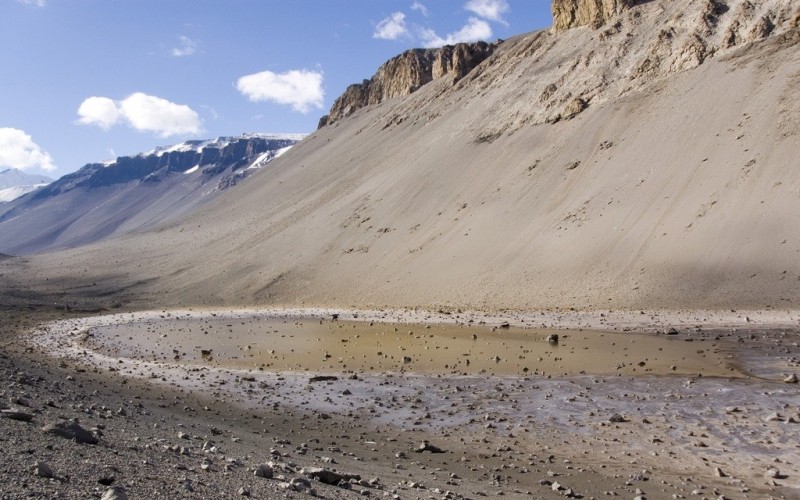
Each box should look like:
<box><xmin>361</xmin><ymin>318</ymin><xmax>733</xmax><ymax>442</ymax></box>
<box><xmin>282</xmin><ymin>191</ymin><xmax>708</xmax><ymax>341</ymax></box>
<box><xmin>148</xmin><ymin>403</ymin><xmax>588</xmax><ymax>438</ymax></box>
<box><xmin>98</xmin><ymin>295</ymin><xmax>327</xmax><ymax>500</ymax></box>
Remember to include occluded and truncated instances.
<box><xmin>236</xmin><ymin>69</ymin><xmax>325</xmax><ymax>113</ymax></box>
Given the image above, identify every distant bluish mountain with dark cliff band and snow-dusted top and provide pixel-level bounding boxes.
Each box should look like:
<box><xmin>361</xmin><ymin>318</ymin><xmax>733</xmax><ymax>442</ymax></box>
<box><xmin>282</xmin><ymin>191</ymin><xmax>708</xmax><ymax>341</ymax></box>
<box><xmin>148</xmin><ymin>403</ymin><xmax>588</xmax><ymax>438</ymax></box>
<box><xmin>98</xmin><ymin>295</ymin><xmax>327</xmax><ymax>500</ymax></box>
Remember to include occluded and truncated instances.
<box><xmin>0</xmin><ymin>134</ymin><xmax>303</xmax><ymax>254</ymax></box>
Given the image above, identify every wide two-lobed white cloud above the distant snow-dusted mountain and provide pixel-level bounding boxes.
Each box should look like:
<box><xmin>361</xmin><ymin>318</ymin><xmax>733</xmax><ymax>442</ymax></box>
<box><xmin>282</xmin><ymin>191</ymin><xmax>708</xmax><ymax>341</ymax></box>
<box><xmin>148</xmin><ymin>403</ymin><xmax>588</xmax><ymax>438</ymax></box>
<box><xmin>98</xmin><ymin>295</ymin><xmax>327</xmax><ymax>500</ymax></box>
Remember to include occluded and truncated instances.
<box><xmin>78</xmin><ymin>92</ymin><xmax>202</xmax><ymax>137</ymax></box>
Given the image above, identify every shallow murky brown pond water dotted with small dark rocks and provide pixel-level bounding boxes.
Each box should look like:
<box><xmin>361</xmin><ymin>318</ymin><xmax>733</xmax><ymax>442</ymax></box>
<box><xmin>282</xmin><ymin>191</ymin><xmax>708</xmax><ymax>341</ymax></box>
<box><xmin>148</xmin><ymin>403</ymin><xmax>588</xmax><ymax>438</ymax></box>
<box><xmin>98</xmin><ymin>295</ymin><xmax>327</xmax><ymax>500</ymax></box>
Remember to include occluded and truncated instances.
<box><xmin>87</xmin><ymin>317</ymin><xmax>742</xmax><ymax>377</ymax></box>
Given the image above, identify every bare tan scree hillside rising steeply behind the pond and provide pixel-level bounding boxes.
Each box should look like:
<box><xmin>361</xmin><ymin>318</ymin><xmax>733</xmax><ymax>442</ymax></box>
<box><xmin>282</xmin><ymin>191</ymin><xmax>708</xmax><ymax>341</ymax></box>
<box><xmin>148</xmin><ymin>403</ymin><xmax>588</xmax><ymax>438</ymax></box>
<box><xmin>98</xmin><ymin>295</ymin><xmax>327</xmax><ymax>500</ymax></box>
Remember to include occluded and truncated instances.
<box><xmin>2</xmin><ymin>0</ymin><xmax>800</xmax><ymax>309</ymax></box>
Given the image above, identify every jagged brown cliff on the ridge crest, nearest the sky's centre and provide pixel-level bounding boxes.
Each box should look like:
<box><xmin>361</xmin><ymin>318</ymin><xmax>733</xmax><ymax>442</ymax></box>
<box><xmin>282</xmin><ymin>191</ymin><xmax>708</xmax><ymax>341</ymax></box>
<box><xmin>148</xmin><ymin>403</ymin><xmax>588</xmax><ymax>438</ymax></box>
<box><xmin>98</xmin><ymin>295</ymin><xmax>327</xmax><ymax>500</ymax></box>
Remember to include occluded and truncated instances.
<box><xmin>319</xmin><ymin>42</ymin><xmax>497</xmax><ymax>127</ymax></box>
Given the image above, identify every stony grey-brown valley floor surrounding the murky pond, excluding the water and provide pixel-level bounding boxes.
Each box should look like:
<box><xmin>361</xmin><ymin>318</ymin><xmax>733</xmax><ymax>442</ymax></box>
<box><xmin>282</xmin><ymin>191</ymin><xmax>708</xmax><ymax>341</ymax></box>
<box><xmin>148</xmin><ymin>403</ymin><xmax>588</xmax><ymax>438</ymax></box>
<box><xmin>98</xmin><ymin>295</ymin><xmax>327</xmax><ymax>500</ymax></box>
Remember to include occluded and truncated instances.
<box><xmin>0</xmin><ymin>304</ymin><xmax>800</xmax><ymax>498</ymax></box>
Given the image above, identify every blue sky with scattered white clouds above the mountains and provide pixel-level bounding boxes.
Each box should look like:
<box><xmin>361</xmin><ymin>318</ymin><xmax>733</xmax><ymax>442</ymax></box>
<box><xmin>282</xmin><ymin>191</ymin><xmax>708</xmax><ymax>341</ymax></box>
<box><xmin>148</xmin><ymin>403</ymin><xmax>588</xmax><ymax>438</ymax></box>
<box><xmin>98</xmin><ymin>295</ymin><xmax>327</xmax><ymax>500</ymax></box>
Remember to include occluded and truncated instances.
<box><xmin>0</xmin><ymin>0</ymin><xmax>552</xmax><ymax>178</ymax></box>
